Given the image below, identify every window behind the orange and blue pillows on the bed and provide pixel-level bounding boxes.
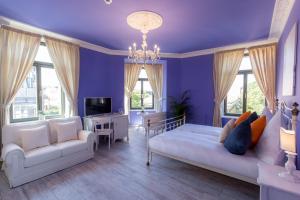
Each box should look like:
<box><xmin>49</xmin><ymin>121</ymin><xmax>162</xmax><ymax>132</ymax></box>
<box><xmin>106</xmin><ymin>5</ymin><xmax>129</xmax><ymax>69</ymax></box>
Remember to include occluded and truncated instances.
<box><xmin>224</xmin><ymin>56</ymin><xmax>265</xmax><ymax>116</ymax></box>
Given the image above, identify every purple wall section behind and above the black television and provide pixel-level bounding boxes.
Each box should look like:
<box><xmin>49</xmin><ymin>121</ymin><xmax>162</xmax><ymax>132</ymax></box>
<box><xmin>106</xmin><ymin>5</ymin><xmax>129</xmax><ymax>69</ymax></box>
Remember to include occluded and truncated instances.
<box><xmin>78</xmin><ymin>48</ymin><xmax>124</xmax><ymax>116</ymax></box>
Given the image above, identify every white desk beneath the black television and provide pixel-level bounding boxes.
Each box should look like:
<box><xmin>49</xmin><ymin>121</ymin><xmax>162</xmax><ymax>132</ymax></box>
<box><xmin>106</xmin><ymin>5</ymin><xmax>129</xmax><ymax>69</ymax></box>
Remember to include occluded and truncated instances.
<box><xmin>83</xmin><ymin>113</ymin><xmax>129</xmax><ymax>142</ymax></box>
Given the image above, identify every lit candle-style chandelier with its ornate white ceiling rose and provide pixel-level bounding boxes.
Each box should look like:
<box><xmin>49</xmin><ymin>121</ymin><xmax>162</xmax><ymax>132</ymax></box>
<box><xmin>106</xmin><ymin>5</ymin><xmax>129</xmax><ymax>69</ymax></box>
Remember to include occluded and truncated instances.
<box><xmin>127</xmin><ymin>11</ymin><xmax>163</xmax><ymax>64</ymax></box>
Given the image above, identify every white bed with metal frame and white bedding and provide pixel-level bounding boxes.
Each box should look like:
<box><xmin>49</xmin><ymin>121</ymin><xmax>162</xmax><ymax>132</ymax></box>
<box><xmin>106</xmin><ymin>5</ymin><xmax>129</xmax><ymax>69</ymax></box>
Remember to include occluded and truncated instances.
<box><xmin>147</xmin><ymin>103</ymin><xmax>298</xmax><ymax>184</ymax></box>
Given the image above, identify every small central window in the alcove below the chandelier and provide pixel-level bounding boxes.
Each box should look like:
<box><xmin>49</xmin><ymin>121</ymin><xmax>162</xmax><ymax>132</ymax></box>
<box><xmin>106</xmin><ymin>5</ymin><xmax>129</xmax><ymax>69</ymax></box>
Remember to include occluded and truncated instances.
<box><xmin>130</xmin><ymin>69</ymin><xmax>154</xmax><ymax>110</ymax></box>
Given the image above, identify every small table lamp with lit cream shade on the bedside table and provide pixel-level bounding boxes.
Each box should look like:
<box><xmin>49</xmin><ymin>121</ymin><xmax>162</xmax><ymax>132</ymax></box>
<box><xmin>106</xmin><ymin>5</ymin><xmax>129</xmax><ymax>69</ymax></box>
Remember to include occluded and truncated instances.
<box><xmin>278</xmin><ymin>127</ymin><xmax>300</xmax><ymax>182</ymax></box>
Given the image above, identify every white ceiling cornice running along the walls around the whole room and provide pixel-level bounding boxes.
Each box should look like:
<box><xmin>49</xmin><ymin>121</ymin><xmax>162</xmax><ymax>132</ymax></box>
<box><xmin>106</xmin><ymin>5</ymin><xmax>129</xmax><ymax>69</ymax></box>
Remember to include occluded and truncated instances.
<box><xmin>0</xmin><ymin>0</ymin><xmax>295</xmax><ymax>58</ymax></box>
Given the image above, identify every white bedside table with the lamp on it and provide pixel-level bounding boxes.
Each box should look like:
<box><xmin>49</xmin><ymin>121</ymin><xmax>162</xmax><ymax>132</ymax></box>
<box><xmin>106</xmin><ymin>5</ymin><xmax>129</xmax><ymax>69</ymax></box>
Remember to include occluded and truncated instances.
<box><xmin>257</xmin><ymin>162</ymin><xmax>300</xmax><ymax>200</ymax></box>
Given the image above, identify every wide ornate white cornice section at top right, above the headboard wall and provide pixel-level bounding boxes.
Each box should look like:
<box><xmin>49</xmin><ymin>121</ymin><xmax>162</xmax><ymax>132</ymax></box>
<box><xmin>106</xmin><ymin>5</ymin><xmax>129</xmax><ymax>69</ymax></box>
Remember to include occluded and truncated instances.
<box><xmin>269</xmin><ymin>0</ymin><xmax>295</xmax><ymax>39</ymax></box>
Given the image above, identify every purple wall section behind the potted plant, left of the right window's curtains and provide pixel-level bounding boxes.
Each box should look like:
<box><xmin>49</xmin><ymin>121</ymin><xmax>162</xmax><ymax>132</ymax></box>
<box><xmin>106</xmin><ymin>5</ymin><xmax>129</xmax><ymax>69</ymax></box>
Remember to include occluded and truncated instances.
<box><xmin>180</xmin><ymin>54</ymin><xmax>214</xmax><ymax>125</ymax></box>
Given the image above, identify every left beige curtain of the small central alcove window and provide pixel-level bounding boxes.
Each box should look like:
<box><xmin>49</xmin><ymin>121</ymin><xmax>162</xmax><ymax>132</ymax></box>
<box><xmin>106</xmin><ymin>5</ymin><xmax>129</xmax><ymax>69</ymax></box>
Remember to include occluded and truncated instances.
<box><xmin>124</xmin><ymin>64</ymin><xmax>142</xmax><ymax>116</ymax></box>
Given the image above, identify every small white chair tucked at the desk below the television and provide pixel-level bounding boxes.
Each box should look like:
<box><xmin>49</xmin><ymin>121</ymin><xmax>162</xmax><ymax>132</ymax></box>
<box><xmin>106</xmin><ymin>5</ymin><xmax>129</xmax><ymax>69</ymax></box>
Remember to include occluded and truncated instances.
<box><xmin>94</xmin><ymin>117</ymin><xmax>113</xmax><ymax>150</ymax></box>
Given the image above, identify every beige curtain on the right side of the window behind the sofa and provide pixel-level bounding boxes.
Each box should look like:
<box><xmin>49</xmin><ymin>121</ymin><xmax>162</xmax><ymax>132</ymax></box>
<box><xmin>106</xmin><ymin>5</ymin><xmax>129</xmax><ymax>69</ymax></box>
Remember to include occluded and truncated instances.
<box><xmin>45</xmin><ymin>37</ymin><xmax>80</xmax><ymax>116</ymax></box>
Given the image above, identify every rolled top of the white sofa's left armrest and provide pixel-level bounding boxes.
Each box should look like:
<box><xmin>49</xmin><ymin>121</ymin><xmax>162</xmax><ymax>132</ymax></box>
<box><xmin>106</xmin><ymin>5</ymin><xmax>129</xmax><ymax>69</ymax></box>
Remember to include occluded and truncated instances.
<box><xmin>1</xmin><ymin>143</ymin><xmax>25</xmax><ymax>164</ymax></box>
